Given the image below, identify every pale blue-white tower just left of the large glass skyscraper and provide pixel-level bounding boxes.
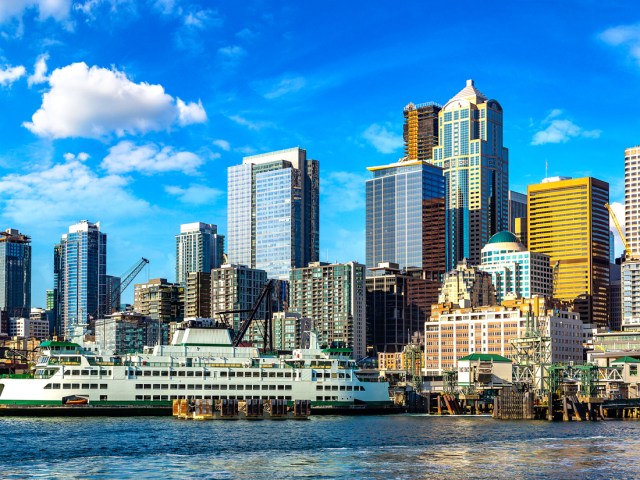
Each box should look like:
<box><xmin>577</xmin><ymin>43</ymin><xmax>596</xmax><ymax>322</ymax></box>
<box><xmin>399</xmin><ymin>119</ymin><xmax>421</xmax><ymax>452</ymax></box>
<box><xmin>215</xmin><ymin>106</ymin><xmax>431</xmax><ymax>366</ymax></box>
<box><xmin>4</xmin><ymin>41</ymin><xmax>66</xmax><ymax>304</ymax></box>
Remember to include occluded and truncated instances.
<box><xmin>176</xmin><ymin>222</ymin><xmax>224</xmax><ymax>287</ymax></box>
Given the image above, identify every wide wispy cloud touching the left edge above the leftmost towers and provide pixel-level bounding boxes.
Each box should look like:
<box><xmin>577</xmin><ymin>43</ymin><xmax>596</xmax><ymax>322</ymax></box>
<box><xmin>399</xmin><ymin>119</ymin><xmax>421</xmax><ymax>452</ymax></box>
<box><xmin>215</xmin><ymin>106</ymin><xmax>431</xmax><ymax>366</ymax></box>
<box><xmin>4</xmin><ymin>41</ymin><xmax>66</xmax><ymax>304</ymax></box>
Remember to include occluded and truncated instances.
<box><xmin>0</xmin><ymin>154</ymin><xmax>150</xmax><ymax>226</ymax></box>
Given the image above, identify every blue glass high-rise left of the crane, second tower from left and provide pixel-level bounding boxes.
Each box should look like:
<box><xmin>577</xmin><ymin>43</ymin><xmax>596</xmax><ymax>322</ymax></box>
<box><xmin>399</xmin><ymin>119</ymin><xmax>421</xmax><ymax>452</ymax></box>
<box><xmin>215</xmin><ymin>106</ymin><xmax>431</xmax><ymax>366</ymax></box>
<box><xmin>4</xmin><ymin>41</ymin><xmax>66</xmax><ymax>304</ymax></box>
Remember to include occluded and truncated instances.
<box><xmin>53</xmin><ymin>220</ymin><xmax>107</xmax><ymax>338</ymax></box>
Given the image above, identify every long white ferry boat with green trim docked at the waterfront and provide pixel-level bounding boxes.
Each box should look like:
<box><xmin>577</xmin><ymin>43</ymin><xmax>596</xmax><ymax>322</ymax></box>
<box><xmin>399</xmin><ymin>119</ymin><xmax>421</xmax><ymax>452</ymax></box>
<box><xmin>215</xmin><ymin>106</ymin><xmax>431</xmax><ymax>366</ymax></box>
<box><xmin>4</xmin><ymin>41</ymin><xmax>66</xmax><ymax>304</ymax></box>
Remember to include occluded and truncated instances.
<box><xmin>0</xmin><ymin>326</ymin><xmax>391</xmax><ymax>408</ymax></box>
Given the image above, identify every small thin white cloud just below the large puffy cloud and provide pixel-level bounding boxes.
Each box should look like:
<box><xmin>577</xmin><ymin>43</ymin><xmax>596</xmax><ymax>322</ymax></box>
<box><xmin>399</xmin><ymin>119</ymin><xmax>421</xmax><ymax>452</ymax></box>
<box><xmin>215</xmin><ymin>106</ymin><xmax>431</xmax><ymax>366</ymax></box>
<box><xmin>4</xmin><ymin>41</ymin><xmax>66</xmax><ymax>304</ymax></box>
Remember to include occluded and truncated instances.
<box><xmin>101</xmin><ymin>141</ymin><xmax>203</xmax><ymax>175</ymax></box>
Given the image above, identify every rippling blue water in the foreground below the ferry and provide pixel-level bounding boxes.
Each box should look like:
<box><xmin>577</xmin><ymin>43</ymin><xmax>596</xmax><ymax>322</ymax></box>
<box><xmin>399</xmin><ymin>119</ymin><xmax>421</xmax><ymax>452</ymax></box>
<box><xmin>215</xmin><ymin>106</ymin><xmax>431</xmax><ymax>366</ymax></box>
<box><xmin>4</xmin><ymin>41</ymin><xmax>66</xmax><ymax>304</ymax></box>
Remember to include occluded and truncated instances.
<box><xmin>0</xmin><ymin>416</ymin><xmax>640</xmax><ymax>479</ymax></box>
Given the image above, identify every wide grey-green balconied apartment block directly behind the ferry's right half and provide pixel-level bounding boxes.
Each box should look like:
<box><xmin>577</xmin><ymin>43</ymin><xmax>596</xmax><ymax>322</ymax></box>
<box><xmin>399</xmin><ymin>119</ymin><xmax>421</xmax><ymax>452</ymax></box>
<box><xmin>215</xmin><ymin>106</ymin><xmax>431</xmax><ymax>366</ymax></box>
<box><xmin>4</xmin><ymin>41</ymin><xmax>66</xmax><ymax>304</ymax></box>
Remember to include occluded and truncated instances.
<box><xmin>289</xmin><ymin>262</ymin><xmax>366</xmax><ymax>359</ymax></box>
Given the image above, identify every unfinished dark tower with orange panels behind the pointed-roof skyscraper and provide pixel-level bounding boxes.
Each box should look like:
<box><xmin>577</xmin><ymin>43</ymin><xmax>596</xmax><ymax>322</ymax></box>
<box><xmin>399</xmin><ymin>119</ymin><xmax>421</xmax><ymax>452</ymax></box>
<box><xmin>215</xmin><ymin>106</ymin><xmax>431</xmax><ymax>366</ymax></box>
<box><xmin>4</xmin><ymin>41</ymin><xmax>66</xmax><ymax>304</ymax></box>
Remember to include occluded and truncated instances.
<box><xmin>403</xmin><ymin>102</ymin><xmax>442</xmax><ymax>162</ymax></box>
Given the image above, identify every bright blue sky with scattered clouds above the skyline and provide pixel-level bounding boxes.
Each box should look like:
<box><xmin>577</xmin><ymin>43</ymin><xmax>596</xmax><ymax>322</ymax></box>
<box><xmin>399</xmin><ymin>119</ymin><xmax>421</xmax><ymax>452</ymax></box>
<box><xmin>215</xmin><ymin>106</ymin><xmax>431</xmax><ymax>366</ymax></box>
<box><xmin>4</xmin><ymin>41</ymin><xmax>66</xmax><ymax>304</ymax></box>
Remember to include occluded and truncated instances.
<box><xmin>0</xmin><ymin>0</ymin><xmax>640</xmax><ymax>306</ymax></box>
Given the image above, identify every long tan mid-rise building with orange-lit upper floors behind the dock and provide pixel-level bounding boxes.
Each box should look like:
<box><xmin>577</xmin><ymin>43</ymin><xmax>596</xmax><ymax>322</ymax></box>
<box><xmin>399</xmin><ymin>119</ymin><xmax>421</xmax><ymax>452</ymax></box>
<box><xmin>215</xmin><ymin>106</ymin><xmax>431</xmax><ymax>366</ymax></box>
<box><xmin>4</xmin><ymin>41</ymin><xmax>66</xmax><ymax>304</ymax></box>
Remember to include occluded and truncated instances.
<box><xmin>425</xmin><ymin>298</ymin><xmax>583</xmax><ymax>375</ymax></box>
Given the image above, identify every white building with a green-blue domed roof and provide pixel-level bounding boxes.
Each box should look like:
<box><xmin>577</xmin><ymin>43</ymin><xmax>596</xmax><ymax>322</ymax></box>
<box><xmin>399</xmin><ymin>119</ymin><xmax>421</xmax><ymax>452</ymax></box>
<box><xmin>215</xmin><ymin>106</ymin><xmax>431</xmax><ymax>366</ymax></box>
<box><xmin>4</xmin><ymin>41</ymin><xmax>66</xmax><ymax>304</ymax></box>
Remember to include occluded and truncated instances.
<box><xmin>479</xmin><ymin>232</ymin><xmax>553</xmax><ymax>303</ymax></box>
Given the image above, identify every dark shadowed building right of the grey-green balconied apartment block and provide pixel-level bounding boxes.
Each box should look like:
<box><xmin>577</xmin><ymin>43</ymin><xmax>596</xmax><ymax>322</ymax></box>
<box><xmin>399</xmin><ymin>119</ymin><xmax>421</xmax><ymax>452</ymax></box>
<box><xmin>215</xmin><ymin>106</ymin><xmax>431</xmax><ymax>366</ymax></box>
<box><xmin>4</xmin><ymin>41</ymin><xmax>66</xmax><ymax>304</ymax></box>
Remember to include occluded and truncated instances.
<box><xmin>366</xmin><ymin>262</ymin><xmax>437</xmax><ymax>354</ymax></box>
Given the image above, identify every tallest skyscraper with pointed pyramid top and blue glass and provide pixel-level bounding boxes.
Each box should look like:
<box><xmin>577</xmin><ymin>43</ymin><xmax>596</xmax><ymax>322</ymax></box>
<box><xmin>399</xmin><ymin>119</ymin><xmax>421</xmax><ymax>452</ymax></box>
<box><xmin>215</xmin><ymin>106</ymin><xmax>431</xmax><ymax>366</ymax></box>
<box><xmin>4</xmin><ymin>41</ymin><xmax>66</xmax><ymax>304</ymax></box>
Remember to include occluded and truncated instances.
<box><xmin>433</xmin><ymin>80</ymin><xmax>509</xmax><ymax>270</ymax></box>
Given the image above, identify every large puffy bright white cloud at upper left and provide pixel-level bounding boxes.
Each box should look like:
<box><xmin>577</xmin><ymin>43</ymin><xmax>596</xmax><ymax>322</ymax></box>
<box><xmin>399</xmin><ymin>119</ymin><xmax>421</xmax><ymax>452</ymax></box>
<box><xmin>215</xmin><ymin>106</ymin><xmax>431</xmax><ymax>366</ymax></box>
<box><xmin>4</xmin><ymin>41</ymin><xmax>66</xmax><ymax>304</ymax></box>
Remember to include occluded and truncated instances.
<box><xmin>23</xmin><ymin>62</ymin><xmax>206</xmax><ymax>138</ymax></box>
